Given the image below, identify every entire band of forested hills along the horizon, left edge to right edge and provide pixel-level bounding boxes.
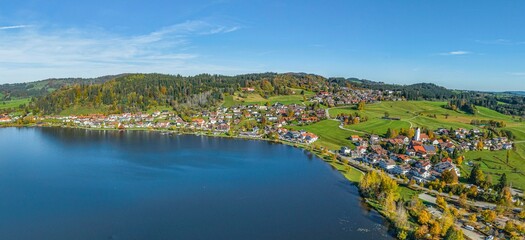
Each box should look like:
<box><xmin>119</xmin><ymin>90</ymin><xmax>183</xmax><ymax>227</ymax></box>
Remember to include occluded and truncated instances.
<box><xmin>17</xmin><ymin>73</ymin><xmax>525</xmax><ymax>116</ymax></box>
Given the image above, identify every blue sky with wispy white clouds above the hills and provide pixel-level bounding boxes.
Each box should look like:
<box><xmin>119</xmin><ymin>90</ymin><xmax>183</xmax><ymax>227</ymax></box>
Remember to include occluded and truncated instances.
<box><xmin>0</xmin><ymin>0</ymin><xmax>525</xmax><ymax>90</ymax></box>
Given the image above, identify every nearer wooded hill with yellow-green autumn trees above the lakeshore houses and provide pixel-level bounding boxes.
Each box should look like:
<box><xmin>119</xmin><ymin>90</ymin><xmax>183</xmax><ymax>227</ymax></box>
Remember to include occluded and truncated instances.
<box><xmin>31</xmin><ymin>73</ymin><xmax>327</xmax><ymax>114</ymax></box>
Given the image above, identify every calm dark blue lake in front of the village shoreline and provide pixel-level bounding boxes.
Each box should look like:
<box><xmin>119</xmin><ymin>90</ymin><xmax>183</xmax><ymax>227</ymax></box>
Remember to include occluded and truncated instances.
<box><xmin>0</xmin><ymin>128</ymin><xmax>392</xmax><ymax>240</ymax></box>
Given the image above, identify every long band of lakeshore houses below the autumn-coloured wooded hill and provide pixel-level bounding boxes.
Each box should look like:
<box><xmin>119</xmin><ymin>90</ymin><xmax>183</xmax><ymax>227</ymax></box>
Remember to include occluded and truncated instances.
<box><xmin>25</xmin><ymin>103</ymin><xmax>320</xmax><ymax>144</ymax></box>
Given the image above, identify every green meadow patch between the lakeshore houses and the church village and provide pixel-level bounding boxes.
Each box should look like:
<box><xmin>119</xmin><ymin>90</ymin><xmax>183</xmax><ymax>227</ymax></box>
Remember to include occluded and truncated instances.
<box><xmin>290</xmin><ymin>120</ymin><xmax>355</xmax><ymax>150</ymax></box>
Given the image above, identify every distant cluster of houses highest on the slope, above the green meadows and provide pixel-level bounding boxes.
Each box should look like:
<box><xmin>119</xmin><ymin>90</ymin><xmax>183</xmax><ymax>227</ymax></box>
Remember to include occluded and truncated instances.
<box><xmin>310</xmin><ymin>87</ymin><xmax>403</xmax><ymax>107</ymax></box>
